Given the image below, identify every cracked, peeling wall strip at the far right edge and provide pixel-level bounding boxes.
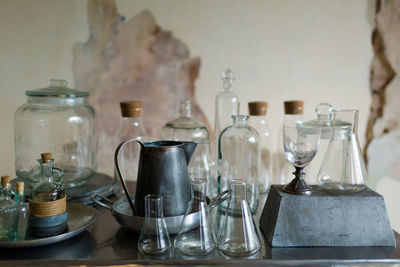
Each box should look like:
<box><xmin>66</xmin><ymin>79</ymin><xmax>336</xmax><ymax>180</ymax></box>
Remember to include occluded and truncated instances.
<box><xmin>364</xmin><ymin>0</ymin><xmax>400</xmax><ymax>187</ymax></box>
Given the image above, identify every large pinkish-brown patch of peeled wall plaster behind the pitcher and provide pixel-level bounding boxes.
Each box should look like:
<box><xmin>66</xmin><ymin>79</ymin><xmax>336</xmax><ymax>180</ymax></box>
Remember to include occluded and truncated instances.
<box><xmin>73</xmin><ymin>0</ymin><xmax>206</xmax><ymax>177</ymax></box>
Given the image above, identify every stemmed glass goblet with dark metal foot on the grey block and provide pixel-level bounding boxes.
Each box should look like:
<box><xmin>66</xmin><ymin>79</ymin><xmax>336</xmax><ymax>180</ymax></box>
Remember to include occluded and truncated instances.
<box><xmin>283</xmin><ymin>122</ymin><xmax>321</xmax><ymax>195</ymax></box>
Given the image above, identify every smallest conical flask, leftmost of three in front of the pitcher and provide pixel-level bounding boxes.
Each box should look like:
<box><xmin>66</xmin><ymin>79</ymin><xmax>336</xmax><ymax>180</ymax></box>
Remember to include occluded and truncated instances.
<box><xmin>138</xmin><ymin>194</ymin><xmax>171</xmax><ymax>255</ymax></box>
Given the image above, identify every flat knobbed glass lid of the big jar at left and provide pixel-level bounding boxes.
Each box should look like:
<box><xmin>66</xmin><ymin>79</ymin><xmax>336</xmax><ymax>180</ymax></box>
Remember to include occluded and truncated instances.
<box><xmin>25</xmin><ymin>79</ymin><xmax>89</xmax><ymax>98</ymax></box>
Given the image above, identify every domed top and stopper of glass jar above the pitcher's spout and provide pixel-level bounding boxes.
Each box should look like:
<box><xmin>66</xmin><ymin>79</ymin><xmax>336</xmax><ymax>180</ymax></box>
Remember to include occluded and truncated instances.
<box><xmin>160</xmin><ymin>100</ymin><xmax>210</xmax><ymax>142</ymax></box>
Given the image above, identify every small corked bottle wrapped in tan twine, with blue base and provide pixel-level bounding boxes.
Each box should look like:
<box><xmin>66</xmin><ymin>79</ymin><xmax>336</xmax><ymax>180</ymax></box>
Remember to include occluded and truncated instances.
<box><xmin>29</xmin><ymin>153</ymin><xmax>68</xmax><ymax>237</ymax></box>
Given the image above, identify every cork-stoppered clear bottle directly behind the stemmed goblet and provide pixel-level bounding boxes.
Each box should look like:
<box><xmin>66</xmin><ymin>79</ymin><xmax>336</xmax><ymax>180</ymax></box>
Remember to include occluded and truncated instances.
<box><xmin>273</xmin><ymin>100</ymin><xmax>304</xmax><ymax>184</ymax></box>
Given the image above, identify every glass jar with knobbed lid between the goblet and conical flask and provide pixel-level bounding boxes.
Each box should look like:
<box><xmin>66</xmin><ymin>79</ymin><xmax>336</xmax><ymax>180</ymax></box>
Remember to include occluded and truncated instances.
<box><xmin>303</xmin><ymin>103</ymin><xmax>334</xmax><ymax>184</ymax></box>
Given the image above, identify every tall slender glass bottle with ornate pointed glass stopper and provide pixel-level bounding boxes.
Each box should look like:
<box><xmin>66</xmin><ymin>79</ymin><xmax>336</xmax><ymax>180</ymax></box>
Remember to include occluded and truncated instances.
<box><xmin>212</xmin><ymin>69</ymin><xmax>239</xmax><ymax>180</ymax></box>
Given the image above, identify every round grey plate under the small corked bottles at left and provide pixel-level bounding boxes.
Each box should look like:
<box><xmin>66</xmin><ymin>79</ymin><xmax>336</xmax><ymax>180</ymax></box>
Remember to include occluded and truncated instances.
<box><xmin>0</xmin><ymin>202</ymin><xmax>97</xmax><ymax>248</ymax></box>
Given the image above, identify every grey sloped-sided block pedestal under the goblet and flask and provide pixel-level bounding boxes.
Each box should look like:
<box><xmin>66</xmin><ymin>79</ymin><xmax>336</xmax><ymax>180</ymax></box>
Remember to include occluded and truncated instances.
<box><xmin>260</xmin><ymin>185</ymin><xmax>396</xmax><ymax>247</ymax></box>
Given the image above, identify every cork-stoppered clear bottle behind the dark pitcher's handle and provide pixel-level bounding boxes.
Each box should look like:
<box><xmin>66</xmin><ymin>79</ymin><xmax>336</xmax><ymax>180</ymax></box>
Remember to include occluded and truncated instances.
<box><xmin>113</xmin><ymin>101</ymin><xmax>148</xmax><ymax>195</ymax></box>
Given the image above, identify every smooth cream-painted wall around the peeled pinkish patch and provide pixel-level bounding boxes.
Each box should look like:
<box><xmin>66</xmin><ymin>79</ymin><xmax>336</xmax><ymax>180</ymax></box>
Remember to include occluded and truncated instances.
<box><xmin>0</xmin><ymin>0</ymin><xmax>390</xmax><ymax>229</ymax></box>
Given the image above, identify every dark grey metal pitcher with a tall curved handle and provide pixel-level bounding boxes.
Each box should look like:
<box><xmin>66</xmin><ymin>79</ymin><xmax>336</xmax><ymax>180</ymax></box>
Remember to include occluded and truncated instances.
<box><xmin>114</xmin><ymin>139</ymin><xmax>196</xmax><ymax>217</ymax></box>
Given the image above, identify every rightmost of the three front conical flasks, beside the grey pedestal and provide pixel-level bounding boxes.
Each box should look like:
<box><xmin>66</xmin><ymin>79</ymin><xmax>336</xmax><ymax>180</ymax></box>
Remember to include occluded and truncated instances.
<box><xmin>218</xmin><ymin>179</ymin><xmax>261</xmax><ymax>257</ymax></box>
